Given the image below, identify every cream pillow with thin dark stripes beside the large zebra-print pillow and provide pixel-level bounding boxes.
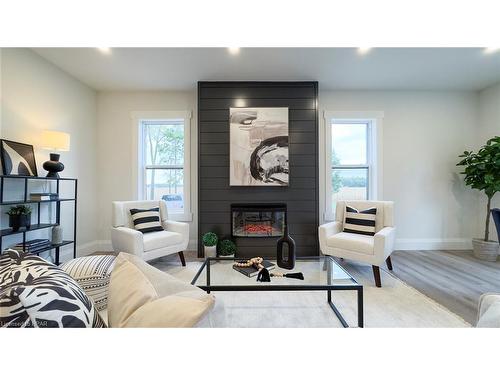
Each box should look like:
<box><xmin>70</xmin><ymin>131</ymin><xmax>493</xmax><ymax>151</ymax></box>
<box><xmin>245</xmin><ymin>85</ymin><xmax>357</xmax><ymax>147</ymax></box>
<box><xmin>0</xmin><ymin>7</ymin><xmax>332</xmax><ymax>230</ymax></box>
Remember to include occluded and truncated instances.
<box><xmin>61</xmin><ymin>255</ymin><xmax>116</xmax><ymax>311</ymax></box>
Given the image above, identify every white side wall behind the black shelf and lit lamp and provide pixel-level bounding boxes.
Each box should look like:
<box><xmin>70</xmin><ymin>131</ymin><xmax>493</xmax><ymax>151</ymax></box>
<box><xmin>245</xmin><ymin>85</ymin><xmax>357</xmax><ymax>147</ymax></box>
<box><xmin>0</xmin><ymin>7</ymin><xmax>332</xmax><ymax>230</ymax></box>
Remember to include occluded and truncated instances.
<box><xmin>1</xmin><ymin>48</ymin><xmax>97</xmax><ymax>260</ymax></box>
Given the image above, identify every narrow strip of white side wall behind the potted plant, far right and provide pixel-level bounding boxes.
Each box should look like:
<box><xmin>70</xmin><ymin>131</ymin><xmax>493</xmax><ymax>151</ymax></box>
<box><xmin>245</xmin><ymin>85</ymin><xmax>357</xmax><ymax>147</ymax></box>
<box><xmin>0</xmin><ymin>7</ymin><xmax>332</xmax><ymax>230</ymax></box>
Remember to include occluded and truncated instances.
<box><xmin>477</xmin><ymin>83</ymin><xmax>500</xmax><ymax>240</ymax></box>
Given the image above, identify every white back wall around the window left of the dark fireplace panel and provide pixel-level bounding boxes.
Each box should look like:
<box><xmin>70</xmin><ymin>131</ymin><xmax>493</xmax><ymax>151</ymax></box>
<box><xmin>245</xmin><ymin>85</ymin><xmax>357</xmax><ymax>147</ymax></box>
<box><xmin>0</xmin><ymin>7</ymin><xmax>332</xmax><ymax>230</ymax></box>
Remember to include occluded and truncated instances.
<box><xmin>97</xmin><ymin>90</ymin><xmax>198</xmax><ymax>250</ymax></box>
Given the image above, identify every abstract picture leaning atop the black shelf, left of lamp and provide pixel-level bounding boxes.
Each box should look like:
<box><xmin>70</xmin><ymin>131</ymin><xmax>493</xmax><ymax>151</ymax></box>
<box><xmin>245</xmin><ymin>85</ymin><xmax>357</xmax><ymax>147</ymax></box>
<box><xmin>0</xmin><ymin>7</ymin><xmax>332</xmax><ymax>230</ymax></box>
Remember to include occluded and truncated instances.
<box><xmin>0</xmin><ymin>139</ymin><xmax>38</xmax><ymax>176</ymax></box>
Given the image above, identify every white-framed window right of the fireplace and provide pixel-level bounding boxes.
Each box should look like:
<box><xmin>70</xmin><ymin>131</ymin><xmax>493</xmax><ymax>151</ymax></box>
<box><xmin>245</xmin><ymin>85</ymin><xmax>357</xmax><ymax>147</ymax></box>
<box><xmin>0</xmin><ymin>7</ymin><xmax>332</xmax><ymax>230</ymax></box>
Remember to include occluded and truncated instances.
<box><xmin>325</xmin><ymin>112</ymin><xmax>381</xmax><ymax>220</ymax></box>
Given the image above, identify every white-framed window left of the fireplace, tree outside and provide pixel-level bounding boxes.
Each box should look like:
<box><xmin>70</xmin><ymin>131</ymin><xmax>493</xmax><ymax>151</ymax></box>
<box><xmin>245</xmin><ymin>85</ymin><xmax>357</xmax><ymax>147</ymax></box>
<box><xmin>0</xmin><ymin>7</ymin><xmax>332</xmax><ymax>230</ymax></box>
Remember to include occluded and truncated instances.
<box><xmin>133</xmin><ymin>112</ymin><xmax>191</xmax><ymax>221</ymax></box>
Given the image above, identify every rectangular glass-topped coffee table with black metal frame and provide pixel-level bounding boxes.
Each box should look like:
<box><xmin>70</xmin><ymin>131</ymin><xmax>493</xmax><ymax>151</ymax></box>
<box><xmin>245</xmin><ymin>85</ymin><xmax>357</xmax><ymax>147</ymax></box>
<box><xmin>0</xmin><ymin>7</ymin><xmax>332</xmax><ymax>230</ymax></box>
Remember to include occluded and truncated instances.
<box><xmin>191</xmin><ymin>256</ymin><xmax>364</xmax><ymax>327</ymax></box>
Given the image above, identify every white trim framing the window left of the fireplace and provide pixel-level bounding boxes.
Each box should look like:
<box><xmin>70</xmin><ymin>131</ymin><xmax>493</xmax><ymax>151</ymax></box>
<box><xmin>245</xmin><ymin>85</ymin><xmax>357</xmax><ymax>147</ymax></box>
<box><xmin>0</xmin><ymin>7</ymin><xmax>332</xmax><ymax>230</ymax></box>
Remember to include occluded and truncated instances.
<box><xmin>131</xmin><ymin>111</ymin><xmax>193</xmax><ymax>222</ymax></box>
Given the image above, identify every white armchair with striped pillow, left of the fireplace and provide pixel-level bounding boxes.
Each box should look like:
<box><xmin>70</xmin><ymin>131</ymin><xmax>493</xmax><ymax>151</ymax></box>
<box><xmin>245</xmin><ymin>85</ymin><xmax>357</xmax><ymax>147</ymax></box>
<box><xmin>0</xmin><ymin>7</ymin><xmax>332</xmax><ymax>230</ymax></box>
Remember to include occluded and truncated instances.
<box><xmin>111</xmin><ymin>200</ymin><xmax>189</xmax><ymax>266</ymax></box>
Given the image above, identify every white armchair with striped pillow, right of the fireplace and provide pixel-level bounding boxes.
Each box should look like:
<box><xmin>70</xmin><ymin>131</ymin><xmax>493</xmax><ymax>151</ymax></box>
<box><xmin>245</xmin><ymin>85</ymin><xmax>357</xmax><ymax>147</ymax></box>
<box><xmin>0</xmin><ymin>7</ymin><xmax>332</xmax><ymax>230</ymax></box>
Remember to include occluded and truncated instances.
<box><xmin>319</xmin><ymin>201</ymin><xmax>396</xmax><ymax>288</ymax></box>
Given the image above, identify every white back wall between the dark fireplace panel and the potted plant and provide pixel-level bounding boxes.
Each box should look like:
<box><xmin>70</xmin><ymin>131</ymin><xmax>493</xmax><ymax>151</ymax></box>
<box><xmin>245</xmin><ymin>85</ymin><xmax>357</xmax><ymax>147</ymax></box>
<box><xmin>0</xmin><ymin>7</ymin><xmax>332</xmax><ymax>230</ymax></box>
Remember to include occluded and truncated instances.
<box><xmin>320</xmin><ymin>91</ymin><xmax>479</xmax><ymax>250</ymax></box>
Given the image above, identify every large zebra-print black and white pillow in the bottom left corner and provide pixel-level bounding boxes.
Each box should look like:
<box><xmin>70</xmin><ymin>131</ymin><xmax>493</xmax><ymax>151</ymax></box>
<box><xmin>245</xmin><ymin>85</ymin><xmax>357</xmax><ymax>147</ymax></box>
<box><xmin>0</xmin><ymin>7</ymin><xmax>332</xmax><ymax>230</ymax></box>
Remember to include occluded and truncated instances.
<box><xmin>0</xmin><ymin>250</ymin><xmax>105</xmax><ymax>328</ymax></box>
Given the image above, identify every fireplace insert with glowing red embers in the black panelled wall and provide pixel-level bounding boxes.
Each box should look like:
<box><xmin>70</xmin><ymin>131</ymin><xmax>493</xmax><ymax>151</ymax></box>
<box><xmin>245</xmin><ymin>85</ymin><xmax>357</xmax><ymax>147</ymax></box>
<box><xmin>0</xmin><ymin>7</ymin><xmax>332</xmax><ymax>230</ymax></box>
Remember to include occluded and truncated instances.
<box><xmin>231</xmin><ymin>203</ymin><xmax>286</xmax><ymax>238</ymax></box>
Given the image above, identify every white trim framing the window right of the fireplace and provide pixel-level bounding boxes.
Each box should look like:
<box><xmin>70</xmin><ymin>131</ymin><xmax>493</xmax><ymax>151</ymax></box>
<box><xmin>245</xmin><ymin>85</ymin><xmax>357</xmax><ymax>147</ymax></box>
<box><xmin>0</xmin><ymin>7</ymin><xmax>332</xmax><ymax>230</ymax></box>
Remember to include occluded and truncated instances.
<box><xmin>319</xmin><ymin>110</ymin><xmax>384</xmax><ymax>223</ymax></box>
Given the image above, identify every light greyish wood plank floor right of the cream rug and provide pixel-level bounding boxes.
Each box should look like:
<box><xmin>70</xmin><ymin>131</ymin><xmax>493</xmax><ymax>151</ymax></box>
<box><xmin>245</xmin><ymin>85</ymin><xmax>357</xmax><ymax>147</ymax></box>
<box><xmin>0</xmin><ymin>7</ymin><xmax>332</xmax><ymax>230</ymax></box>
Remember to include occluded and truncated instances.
<box><xmin>391</xmin><ymin>250</ymin><xmax>500</xmax><ymax>324</ymax></box>
